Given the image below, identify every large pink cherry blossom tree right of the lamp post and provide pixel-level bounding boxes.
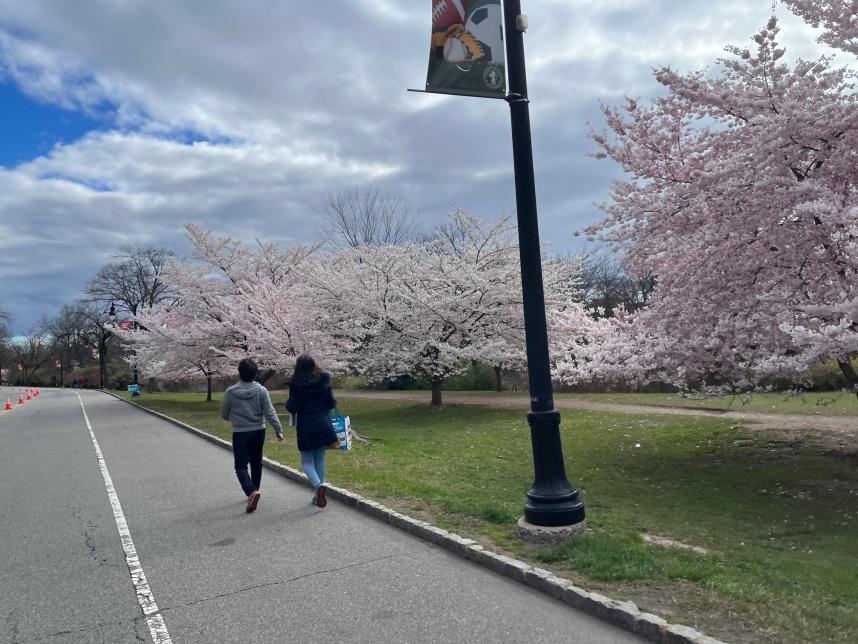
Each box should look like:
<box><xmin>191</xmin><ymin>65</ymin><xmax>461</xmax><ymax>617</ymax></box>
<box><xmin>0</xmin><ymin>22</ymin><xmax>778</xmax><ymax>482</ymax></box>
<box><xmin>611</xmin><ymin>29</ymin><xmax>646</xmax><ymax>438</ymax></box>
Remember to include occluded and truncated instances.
<box><xmin>587</xmin><ymin>8</ymin><xmax>858</xmax><ymax>389</ymax></box>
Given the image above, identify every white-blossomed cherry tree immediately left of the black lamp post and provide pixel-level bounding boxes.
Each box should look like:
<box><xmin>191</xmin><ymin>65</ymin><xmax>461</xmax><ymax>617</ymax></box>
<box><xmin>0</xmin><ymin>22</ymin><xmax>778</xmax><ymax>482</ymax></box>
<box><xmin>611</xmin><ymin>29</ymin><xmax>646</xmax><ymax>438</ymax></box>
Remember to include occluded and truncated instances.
<box><xmin>310</xmin><ymin>212</ymin><xmax>523</xmax><ymax>406</ymax></box>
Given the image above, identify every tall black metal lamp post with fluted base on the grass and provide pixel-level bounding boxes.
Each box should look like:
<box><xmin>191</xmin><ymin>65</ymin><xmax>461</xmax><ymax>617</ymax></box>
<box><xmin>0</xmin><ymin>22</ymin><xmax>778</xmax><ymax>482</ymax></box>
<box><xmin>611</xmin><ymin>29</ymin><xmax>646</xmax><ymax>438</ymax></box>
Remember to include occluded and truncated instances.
<box><xmin>503</xmin><ymin>0</ymin><xmax>584</xmax><ymax>526</ymax></box>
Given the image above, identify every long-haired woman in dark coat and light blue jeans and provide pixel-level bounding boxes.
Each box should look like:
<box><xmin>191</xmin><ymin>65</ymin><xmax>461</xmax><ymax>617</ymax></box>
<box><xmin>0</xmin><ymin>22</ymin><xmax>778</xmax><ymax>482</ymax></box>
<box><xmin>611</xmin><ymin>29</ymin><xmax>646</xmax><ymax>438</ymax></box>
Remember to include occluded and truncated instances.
<box><xmin>286</xmin><ymin>355</ymin><xmax>340</xmax><ymax>508</ymax></box>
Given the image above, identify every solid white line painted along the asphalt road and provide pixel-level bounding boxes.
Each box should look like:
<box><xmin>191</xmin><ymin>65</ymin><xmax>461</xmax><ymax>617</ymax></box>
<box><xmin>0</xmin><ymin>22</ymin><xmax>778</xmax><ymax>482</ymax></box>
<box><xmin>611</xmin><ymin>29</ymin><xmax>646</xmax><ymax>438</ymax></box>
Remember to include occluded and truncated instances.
<box><xmin>74</xmin><ymin>392</ymin><xmax>173</xmax><ymax>644</ymax></box>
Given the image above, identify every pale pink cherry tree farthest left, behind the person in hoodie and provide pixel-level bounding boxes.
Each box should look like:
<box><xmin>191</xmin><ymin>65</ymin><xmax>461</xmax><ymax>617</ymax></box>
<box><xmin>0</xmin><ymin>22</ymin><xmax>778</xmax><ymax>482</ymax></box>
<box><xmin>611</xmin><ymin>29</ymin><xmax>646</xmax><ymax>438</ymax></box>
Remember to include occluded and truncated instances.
<box><xmin>123</xmin><ymin>225</ymin><xmax>319</xmax><ymax>390</ymax></box>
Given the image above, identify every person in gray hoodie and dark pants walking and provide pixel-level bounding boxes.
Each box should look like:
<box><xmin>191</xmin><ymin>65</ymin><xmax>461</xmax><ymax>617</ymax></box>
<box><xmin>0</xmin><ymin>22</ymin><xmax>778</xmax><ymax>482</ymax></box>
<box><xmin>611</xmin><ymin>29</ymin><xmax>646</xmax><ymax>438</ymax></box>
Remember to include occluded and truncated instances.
<box><xmin>220</xmin><ymin>358</ymin><xmax>283</xmax><ymax>512</ymax></box>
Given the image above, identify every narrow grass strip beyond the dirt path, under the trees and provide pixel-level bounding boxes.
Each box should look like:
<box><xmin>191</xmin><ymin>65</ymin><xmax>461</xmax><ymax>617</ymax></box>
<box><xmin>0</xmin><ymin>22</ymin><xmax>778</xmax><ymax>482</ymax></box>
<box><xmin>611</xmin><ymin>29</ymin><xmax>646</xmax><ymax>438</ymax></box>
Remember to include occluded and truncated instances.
<box><xmin>448</xmin><ymin>391</ymin><xmax>858</xmax><ymax>418</ymax></box>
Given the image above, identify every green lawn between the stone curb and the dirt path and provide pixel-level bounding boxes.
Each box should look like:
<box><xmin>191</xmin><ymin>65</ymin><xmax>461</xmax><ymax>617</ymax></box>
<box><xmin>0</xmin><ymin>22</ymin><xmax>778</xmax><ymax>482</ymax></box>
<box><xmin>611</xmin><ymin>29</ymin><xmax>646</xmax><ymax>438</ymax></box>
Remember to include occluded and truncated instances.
<box><xmin>118</xmin><ymin>394</ymin><xmax>858</xmax><ymax>643</ymax></box>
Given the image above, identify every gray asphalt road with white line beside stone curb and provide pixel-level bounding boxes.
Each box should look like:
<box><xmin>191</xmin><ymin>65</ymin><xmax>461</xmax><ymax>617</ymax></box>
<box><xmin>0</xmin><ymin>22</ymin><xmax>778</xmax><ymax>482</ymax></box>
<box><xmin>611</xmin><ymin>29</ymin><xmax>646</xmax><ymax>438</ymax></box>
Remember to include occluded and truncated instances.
<box><xmin>0</xmin><ymin>388</ymin><xmax>640</xmax><ymax>644</ymax></box>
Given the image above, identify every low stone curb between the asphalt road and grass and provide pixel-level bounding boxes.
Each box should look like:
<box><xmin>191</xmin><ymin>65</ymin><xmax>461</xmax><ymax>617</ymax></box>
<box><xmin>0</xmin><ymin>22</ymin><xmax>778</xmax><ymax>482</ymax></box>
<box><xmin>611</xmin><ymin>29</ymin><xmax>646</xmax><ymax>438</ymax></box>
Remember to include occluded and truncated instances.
<box><xmin>104</xmin><ymin>391</ymin><xmax>725</xmax><ymax>644</ymax></box>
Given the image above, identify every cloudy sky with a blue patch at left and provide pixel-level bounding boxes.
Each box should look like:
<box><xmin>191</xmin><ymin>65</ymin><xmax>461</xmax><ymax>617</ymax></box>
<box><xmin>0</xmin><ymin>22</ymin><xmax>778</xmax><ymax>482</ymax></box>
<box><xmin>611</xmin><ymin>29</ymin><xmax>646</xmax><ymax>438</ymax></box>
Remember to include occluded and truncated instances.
<box><xmin>0</xmin><ymin>0</ymin><xmax>825</xmax><ymax>334</ymax></box>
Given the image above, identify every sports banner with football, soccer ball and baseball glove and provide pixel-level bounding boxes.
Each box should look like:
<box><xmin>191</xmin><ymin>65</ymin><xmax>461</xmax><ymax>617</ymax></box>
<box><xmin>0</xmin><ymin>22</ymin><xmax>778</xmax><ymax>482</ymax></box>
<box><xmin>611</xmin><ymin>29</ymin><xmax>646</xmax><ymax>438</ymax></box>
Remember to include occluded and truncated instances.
<box><xmin>426</xmin><ymin>0</ymin><xmax>506</xmax><ymax>98</ymax></box>
